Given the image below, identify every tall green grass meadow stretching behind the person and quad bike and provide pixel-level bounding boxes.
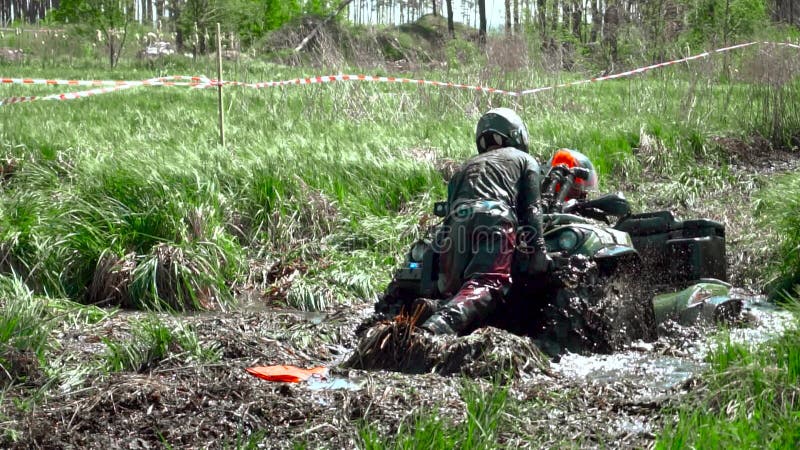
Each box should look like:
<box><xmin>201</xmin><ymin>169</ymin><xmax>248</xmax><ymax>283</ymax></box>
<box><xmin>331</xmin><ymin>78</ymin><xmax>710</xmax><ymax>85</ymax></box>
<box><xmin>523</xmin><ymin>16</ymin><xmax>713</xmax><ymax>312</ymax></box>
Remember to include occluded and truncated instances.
<box><xmin>0</xmin><ymin>41</ymin><xmax>800</xmax><ymax>310</ymax></box>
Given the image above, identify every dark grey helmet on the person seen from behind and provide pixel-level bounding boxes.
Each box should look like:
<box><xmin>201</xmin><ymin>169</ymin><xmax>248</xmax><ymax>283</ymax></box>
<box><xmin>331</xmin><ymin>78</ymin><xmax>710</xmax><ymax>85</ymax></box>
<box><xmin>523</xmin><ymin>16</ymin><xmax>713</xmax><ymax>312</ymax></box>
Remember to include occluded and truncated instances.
<box><xmin>475</xmin><ymin>108</ymin><xmax>528</xmax><ymax>153</ymax></box>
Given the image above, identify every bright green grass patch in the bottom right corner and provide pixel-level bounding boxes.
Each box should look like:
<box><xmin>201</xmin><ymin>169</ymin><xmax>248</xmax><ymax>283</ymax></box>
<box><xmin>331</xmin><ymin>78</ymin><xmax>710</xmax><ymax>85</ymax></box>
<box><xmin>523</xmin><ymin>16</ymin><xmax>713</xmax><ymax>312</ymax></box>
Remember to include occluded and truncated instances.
<box><xmin>656</xmin><ymin>298</ymin><xmax>800</xmax><ymax>449</ymax></box>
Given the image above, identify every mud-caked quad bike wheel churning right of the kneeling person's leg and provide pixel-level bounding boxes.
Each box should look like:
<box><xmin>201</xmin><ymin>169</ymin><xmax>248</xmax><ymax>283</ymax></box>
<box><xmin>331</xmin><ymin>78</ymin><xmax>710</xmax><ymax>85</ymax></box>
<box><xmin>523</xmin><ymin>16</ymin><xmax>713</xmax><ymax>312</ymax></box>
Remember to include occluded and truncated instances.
<box><xmin>536</xmin><ymin>270</ymin><xmax>656</xmax><ymax>356</ymax></box>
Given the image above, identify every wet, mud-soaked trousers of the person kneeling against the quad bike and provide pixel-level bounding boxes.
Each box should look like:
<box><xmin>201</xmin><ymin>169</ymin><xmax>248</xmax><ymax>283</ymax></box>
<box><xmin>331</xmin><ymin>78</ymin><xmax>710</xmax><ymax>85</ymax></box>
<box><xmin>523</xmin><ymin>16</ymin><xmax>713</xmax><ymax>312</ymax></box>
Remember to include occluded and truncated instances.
<box><xmin>423</xmin><ymin>213</ymin><xmax>516</xmax><ymax>334</ymax></box>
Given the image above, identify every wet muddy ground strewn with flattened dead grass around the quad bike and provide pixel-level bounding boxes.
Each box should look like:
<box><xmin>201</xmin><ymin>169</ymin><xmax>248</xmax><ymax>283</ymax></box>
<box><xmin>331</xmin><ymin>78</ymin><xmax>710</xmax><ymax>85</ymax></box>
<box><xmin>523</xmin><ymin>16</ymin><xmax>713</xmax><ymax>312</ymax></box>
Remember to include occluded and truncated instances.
<box><xmin>0</xmin><ymin>142</ymin><xmax>797</xmax><ymax>449</ymax></box>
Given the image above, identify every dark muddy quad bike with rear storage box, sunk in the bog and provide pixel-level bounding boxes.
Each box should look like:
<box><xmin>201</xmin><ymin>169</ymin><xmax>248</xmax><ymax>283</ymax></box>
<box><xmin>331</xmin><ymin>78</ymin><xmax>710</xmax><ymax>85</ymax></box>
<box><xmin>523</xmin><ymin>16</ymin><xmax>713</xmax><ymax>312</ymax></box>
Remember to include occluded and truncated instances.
<box><xmin>375</xmin><ymin>165</ymin><xmax>741</xmax><ymax>356</ymax></box>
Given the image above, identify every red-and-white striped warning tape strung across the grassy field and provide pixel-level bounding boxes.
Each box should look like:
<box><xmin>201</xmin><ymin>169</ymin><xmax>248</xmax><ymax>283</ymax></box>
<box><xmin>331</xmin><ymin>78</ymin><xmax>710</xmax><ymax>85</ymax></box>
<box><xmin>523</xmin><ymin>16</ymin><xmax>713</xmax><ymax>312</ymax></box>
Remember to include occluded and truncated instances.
<box><xmin>0</xmin><ymin>41</ymin><xmax>800</xmax><ymax>106</ymax></box>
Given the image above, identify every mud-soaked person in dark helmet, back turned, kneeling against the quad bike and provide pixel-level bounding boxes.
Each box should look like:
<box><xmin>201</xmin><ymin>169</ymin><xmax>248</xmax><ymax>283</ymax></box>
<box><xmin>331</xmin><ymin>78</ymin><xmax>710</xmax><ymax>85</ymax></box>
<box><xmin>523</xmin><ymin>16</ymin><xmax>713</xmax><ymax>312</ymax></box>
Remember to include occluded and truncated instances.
<box><xmin>422</xmin><ymin>108</ymin><xmax>550</xmax><ymax>334</ymax></box>
